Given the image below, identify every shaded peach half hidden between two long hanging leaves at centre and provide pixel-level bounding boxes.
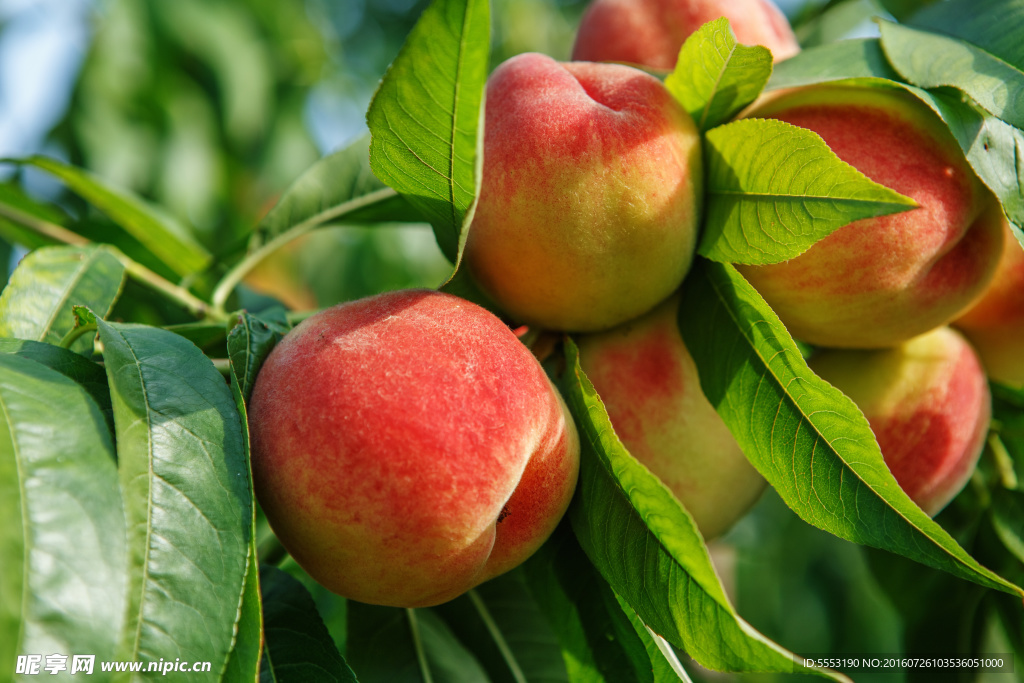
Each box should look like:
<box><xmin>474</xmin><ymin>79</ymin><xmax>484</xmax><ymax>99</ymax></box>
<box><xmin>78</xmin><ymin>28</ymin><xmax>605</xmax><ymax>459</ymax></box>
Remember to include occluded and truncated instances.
<box><xmin>578</xmin><ymin>296</ymin><xmax>765</xmax><ymax>539</ymax></box>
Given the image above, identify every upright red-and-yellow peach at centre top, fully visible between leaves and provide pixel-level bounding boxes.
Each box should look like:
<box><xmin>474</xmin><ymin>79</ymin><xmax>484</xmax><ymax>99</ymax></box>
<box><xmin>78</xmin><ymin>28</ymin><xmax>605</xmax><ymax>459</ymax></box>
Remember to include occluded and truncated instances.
<box><xmin>466</xmin><ymin>54</ymin><xmax>701</xmax><ymax>331</ymax></box>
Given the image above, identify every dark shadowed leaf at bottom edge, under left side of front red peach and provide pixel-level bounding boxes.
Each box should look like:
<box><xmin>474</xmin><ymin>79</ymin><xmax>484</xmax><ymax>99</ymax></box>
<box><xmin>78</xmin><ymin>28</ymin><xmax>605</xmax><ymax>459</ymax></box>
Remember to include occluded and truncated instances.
<box><xmin>259</xmin><ymin>564</ymin><xmax>356</xmax><ymax>683</ymax></box>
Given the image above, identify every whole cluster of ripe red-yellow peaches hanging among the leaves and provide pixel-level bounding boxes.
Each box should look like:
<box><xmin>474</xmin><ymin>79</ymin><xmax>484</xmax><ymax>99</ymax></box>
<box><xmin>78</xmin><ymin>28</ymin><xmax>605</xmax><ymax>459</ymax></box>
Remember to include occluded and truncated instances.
<box><xmin>243</xmin><ymin>0</ymin><xmax>1024</xmax><ymax>606</ymax></box>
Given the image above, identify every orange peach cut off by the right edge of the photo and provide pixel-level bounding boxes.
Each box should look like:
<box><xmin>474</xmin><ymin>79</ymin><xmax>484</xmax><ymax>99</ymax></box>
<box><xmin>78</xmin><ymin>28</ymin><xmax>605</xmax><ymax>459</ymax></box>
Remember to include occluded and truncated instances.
<box><xmin>953</xmin><ymin>224</ymin><xmax>1024</xmax><ymax>388</ymax></box>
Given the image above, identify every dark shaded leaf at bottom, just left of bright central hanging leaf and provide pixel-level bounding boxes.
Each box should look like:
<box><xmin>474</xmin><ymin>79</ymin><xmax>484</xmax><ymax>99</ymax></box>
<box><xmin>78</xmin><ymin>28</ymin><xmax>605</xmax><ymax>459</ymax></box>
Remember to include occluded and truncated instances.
<box><xmin>525</xmin><ymin>524</ymin><xmax>679</xmax><ymax>683</ymax></box>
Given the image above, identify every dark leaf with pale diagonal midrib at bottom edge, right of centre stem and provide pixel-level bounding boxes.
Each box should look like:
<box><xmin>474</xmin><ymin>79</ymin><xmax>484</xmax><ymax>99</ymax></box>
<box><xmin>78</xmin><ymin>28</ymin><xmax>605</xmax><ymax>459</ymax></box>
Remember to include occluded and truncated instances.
<box><xmin>433</xmin><ymin>570</ymin><xmax>569</xmax><ymax>683</ymax></box>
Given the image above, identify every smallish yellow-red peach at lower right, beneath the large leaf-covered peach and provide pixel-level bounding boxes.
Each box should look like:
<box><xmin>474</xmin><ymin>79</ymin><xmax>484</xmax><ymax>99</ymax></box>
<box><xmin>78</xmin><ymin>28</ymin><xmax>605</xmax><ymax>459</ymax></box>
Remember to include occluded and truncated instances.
<box><xmin>809</xmin><ymin>328</ymin><xmax>991</xmax><ymax>516</ymax></box>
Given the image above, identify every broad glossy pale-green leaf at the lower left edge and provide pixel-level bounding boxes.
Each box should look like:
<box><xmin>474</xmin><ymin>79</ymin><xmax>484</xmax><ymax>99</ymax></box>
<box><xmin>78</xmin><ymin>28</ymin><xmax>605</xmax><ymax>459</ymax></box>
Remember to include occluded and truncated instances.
<box><xmin>0</xmin><ymin>353</ymin><xmax>125</xmax><ymax>677</ymax></box>
